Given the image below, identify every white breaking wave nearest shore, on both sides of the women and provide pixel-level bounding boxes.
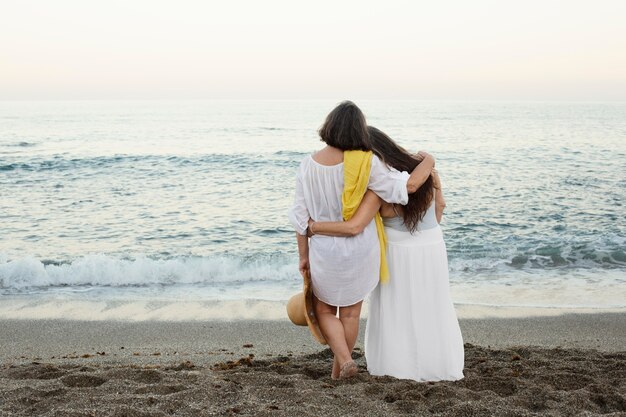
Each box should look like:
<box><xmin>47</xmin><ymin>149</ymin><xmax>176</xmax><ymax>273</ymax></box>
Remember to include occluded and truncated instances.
<box><xmin>0</xmin><ymin>247</ymin><xmax>626</xmax><ymax>294</ymax></box>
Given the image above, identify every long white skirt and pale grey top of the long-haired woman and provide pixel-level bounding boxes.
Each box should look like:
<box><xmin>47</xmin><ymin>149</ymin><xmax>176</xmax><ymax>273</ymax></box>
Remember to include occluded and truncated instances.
<box><xmin>365</xmin><ymin>197</ymin><xmax>464</xmax><ymax>381</ymax></box>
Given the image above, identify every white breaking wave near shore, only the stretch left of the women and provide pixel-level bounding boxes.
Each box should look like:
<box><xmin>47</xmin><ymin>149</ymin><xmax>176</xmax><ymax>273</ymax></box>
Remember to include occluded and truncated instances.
<box><xmin>0</xmin><ymin>254</ymin><xmax>298</xmax><ymax>293</ymax></box>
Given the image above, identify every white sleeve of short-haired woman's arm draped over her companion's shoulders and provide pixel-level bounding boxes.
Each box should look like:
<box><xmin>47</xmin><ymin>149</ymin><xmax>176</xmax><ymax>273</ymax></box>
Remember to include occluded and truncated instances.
<box><xmin>366</xmin><ymin>155</ymin><xmax>409</xmax><ymax>204</ymax></box>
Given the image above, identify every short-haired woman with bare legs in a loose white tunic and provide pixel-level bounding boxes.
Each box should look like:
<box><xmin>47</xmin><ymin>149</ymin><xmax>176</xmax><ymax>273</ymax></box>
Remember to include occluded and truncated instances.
<box><xmin>289</xmin><ymin>102</ymin><xmax>434</xmax><ymax>378</ymax></box>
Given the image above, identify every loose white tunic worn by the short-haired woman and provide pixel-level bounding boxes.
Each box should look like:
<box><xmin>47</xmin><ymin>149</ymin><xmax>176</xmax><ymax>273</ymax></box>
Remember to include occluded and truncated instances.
<box><xmin>289</xmin><ymin>155</ymin><xmax>409</xmax><ymax>307</ymax></box>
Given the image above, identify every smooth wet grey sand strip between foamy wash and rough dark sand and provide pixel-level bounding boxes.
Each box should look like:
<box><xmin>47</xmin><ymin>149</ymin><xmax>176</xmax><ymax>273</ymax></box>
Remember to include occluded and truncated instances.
<box><xmin>0</xmin><ymin>312</ymin><xmax>626</xmax><ymax>364</ymax></box>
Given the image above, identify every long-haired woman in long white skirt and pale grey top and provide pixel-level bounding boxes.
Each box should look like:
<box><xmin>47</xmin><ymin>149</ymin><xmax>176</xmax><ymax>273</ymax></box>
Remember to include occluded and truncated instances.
<box><xmin>309</xmin><ymin>127</ymin><xmax>464</xmax><ymax>381</ymax></box>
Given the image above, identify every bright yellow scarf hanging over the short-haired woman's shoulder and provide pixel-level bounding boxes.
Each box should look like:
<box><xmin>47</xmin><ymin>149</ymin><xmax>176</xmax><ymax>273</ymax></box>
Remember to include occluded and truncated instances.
<box><xmin>341</xmin><ymin>151</ymin><xmax>389</xmax><ymax>283</ymax></box>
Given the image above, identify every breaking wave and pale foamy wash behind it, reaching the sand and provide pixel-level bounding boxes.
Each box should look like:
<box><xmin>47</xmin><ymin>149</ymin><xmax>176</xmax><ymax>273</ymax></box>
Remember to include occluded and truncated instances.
<box><xmin>0</xmin><ymin>255</ymin><xmax>626</xmax><ymax>321</ymax></box>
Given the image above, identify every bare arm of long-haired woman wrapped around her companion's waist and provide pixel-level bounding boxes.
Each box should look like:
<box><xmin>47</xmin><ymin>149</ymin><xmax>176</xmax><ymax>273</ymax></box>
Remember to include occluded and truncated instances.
<box><xmin>309</xmin><ymin>191</ymin><xmax>382</xmax><ymax>236</ymax></box>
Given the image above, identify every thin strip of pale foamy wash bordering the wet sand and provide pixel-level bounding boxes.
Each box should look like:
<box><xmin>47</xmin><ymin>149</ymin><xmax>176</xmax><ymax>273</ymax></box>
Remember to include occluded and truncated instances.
<box><xmin>0</xmin><ymin>288</ymin><xmax>626</xmax><ymax>323</ymax></box>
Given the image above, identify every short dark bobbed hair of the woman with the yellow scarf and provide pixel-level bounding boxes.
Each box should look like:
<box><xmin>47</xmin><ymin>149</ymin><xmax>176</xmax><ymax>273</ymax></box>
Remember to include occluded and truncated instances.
<box><xmin>319</xmin><ymin>101</ymin><xmax>372</xmax><ymax>151</ymax></box>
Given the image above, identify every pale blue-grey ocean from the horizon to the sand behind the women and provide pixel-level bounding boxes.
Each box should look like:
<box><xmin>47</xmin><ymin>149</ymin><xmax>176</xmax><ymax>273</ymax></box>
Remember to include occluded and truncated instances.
<box><xmin>0</xmin><ymin>100</ymin><xmax>626</xmax><ymax>320</ymax></box>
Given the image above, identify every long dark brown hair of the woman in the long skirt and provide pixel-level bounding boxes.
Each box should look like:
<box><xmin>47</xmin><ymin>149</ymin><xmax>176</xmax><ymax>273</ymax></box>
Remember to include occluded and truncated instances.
<box><xmin>368</xmin><ymin>126</ymin><xmax>434</xmax><ymax>232</ymax></box>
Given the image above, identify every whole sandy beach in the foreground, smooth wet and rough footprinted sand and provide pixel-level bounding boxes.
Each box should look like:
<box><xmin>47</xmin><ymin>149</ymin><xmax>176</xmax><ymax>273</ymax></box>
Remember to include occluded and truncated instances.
<box><xmin>0</xmin><ymin>313</ymin><xmax>626</xmax><ymax>416</ymax></box>
